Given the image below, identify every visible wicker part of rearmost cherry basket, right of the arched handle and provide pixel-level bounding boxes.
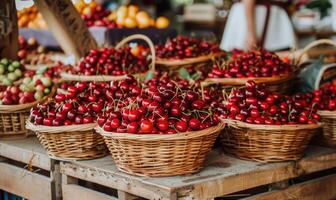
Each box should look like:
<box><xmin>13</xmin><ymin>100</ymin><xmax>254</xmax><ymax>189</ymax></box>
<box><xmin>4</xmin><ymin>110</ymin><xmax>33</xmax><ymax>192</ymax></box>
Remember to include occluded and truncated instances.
<box><xmin>155</xmin><ymin>52</ymin><xmax>226</xmax><ymax>70</ymax></box>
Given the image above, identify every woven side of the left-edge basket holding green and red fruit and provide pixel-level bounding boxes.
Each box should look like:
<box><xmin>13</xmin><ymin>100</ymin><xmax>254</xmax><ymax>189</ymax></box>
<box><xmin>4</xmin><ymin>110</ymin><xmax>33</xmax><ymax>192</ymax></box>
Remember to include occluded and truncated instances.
<box><xmin>0</xmin><ymin>110</ymin><xmax>29</xmax><ymax>139</ymax></box>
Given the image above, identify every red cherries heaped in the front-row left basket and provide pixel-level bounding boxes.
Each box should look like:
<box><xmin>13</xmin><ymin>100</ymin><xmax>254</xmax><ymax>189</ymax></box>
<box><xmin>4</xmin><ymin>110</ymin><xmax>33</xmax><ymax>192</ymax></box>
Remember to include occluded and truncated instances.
<box><xmin>30</xmin><ymin>82</ymin><xmax>111</xmax><ymax>126</ymax></box>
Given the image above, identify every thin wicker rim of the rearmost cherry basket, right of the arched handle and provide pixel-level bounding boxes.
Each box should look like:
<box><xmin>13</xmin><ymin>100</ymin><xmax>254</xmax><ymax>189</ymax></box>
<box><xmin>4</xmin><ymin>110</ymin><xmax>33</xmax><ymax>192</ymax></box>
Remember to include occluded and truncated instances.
<box><xmin>156</xmin><ymin>51</ymin><xmax>226</xmax><ymax>66</ymax></box>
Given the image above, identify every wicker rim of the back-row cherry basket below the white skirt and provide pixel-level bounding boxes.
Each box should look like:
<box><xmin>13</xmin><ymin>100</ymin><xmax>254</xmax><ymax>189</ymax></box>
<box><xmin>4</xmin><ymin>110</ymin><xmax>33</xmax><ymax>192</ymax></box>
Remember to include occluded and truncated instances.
<box><xmin>202</xmin><ymin>73</ymin><xmax>294</xmax><ymax>85</ymax></box>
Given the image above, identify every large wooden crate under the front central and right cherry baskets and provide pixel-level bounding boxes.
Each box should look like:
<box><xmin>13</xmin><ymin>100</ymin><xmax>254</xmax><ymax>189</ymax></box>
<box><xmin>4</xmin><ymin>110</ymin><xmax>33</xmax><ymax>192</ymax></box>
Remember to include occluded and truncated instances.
<box><xmin>61</xmin><ymin>146</ymin><xmax>336</xmax><ymax>200</ymax></box>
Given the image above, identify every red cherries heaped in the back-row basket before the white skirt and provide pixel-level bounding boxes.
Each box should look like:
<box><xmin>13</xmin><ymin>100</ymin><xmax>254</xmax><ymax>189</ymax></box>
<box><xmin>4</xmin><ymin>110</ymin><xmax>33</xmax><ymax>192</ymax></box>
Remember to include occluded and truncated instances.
<box><xmin>208</xmin><ymin>50</ymin><xmax>293</xmax><ymax>78</ymax></box>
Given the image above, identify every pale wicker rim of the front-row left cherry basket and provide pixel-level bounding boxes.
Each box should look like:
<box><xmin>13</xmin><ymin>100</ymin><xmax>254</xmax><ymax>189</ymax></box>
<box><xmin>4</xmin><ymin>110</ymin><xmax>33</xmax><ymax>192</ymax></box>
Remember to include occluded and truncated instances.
<box><xmin>25</xmin><ymin>119</ymin><xmax>97</xmax><ymax>133</ymax></box>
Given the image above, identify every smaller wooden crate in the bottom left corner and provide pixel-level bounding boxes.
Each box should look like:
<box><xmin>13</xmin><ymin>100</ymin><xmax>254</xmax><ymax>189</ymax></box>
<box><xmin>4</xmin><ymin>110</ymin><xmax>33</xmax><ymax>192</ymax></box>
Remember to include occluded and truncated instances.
<box><xmin>0</xmin><ymin>137</ymin><xmax>61</xmax><ymax>200</ymax></box>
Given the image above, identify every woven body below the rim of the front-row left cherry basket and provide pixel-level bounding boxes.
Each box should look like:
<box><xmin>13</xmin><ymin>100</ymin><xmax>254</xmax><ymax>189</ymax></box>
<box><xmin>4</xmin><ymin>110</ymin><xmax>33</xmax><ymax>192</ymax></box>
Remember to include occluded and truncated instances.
<box><xmin>35</xmin><ymin>130</ymin><xmax>108</xmax><ymax>160</ymax></box>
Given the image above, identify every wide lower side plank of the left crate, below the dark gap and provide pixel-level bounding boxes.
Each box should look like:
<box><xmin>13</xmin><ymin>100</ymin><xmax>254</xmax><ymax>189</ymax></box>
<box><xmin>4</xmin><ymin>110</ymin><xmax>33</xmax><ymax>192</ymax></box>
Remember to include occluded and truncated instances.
<box><xmin>0</xmin><ymin>163</ymin><xmax>51</xmax><ymax>200</ymax></box>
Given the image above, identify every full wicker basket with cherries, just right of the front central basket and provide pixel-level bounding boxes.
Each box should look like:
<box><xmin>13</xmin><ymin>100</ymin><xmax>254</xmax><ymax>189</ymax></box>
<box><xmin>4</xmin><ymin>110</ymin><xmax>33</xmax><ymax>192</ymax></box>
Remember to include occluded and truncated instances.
<box><xmin>222</xmin><ymin>81</ymin><xmax>320</xmax><ymax>162</ymax></box>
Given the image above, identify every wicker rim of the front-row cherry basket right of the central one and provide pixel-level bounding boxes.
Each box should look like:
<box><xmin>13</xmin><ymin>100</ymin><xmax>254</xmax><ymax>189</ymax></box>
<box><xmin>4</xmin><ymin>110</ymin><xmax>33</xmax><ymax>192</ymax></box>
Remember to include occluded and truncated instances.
<box><xmin>221</xmin><ymin>119</ymin><xmax>322</xmax><ymax>131</ymax></box>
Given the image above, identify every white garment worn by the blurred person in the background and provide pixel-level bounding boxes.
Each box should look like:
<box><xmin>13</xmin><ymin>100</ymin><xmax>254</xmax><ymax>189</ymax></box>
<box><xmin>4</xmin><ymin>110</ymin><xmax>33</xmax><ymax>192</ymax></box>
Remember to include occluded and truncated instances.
<box><xmin>220</xmin><ymin>3</ymin><xmax>296</xmax><ymax>51</ymax></box>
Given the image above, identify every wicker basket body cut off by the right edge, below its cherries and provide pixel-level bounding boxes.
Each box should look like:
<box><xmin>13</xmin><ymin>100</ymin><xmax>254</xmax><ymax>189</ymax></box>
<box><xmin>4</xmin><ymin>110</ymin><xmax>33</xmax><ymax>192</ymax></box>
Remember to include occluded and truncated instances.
<box><xmin>316</xmin><ymin>110</ymin><xmax>336</xmax><ymax>147</ymax></box>
